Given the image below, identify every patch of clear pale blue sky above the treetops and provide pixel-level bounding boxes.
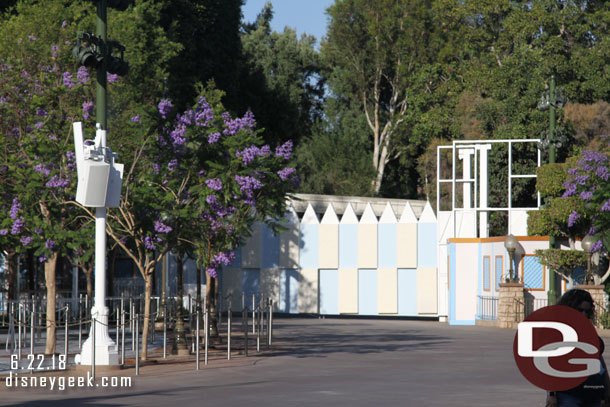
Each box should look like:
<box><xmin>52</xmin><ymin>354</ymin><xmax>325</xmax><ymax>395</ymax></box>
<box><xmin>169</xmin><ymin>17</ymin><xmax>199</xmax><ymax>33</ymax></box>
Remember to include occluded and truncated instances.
<box><xmin>242</xmin><ymin>0</ymin><xmax>334</xmax><ymax>45</ymax></box>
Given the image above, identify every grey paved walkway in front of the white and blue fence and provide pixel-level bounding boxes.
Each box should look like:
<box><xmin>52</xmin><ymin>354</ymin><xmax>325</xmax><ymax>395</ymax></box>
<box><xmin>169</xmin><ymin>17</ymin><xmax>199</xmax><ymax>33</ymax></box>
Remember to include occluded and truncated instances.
<box><xmin>0</xmin><ymin>318</ymin><xmax>564</xmax><ymax>407</ymax></box>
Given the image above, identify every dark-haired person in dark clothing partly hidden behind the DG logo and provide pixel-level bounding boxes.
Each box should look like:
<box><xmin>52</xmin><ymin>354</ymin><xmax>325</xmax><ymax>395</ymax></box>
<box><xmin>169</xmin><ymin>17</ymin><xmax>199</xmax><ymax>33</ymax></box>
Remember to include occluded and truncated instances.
<box><xmin>546</xmin><ymin>288</ymin><xmax>610</xmax><ymax>407</ymax></box>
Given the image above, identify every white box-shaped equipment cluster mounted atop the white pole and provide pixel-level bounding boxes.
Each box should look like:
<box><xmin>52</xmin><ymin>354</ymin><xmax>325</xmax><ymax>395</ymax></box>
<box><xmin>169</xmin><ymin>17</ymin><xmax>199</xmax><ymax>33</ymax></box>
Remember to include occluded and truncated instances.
<box><xmin>73</xmin><ymin>122</ymin><xmax>123</xmax><ymax>208</ymax></box>
